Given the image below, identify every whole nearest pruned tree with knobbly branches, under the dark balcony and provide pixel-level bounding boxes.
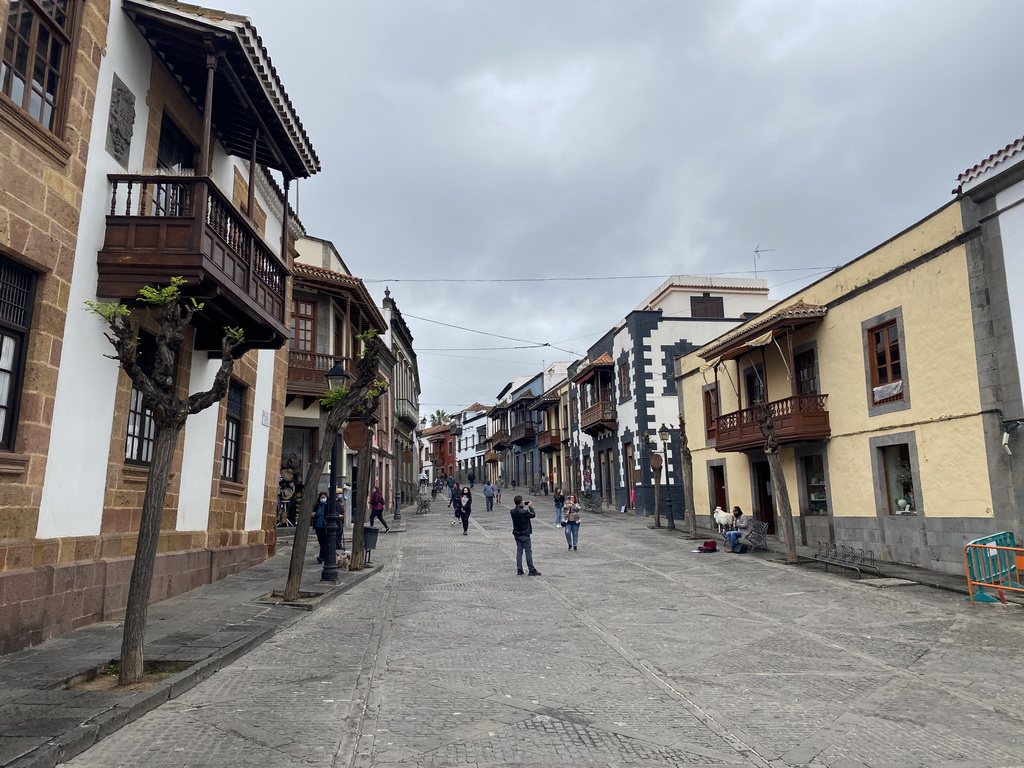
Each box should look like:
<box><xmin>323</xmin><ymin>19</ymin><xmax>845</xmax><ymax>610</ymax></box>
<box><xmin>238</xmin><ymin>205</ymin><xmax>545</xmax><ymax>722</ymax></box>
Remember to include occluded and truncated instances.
<box><xmin>85</xmin><ymin>278</ymin><xmax>244</xmax><ymax>685</ymax></box>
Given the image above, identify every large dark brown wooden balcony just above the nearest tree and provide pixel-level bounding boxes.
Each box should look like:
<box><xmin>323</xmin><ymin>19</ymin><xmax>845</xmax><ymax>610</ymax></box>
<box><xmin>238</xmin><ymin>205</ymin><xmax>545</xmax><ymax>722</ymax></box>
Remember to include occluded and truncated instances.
<box><xmin>96</xmin><ymin>174</ymin><xmax>289</xmax><ymax>350</ymax></box>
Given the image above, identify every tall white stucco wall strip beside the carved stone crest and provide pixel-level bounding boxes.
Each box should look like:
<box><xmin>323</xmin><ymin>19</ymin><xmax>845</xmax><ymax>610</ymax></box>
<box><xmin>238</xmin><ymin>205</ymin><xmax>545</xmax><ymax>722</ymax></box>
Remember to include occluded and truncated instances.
<box><xmin>36</xmin><ymin>9</ymin><xmax>151</xmax><ymax>539</ymax></box>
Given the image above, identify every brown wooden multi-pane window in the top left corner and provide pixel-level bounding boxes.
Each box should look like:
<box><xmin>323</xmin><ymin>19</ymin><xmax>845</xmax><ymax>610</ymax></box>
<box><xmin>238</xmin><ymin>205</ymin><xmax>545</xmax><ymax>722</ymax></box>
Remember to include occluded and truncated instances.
<box><xmin>0</xmin><ymin>0</ymin><xmax>79</xmax><ymax>133</ymax></box>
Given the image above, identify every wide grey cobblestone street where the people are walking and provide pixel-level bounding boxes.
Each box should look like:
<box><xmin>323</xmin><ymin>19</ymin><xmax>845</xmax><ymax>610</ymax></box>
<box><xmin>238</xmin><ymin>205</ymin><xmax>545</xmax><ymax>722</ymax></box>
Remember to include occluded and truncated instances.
<box><xmin>71</xmin><ymin>500</ymin><xmax>1024</xmax><ymax>768</ymax></box>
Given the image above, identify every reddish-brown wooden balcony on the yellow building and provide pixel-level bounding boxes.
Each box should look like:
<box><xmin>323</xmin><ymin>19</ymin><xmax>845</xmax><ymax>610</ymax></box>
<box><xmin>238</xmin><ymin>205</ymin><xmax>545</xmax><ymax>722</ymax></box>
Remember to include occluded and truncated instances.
<box><xmin>715</xmin><ymin>394</ymin><xmax>831</xmax><ymax>452</ymax></box>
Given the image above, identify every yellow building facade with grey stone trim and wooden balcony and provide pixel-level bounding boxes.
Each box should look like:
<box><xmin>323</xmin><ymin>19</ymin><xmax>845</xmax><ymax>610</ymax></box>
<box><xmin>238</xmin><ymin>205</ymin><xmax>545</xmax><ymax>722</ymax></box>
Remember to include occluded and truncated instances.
<box><xmin>676</xmin><ymin>201</ymin><xmax>1020</xmax><ymax>572</ymax></box>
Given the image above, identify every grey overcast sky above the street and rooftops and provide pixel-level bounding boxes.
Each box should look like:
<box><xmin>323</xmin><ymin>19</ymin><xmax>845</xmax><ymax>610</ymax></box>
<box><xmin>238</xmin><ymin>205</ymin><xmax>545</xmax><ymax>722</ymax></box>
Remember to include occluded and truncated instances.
<box><xmin>209</xmin><ymin>0</ymin><xmax>1024</xmax><ymax>415</ymax></box>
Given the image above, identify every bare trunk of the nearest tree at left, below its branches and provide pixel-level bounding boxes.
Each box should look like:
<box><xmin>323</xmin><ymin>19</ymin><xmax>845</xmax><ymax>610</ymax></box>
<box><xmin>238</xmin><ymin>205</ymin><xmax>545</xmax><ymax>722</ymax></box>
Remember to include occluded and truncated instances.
<box><xmin>118</xmin><ymin>425</ymin><xmax>183</xmax><ymax>685</ymax></box>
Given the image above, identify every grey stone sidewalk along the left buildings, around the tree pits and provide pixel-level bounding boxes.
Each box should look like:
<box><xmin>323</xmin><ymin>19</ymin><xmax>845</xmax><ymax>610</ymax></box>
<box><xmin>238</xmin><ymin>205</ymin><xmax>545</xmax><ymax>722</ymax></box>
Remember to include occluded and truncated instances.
<box><xmin>0</xmin><ymin>537</ymin><xmax>379</xmax><ymax>768</ymax></box>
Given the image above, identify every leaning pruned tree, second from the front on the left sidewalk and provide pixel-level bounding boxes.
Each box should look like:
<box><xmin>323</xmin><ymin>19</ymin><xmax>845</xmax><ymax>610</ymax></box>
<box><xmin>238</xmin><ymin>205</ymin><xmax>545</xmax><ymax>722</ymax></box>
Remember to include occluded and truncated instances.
<box><xmin>284</xmin><ymin>330</ymin><xmax>388</xmax><ymax>600</ymax></box>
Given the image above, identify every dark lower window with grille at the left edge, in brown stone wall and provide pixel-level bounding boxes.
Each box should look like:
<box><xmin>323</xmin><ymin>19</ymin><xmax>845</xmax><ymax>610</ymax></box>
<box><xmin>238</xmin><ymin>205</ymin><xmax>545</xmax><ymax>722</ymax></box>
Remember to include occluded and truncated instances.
<box><xmin>0</xmin><ymin>256</ymin><xmax>36</xmax><ymax>451</ymax></box>
